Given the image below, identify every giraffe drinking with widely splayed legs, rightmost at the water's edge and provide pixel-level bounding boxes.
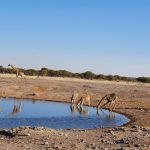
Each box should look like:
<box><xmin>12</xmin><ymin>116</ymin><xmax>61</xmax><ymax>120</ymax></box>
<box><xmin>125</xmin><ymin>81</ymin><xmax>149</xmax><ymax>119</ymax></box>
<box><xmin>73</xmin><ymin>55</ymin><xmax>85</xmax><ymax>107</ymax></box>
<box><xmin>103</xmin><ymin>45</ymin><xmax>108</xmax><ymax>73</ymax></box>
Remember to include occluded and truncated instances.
<box><xmin>97</xmin><ymin>93</ymin><xmax>118</xmax><ymax>111</ymax></box>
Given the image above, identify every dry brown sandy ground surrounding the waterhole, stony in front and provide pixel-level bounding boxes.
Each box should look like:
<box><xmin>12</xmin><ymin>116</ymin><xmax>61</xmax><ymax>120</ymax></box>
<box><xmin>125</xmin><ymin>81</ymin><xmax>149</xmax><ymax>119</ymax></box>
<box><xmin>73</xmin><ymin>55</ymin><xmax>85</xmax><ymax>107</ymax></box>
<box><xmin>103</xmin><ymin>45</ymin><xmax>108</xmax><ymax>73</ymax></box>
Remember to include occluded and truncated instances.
<box><xmin>0</xmin><ymin>75</ymin><xmax>150</xmax><ymax>150</ymax></box>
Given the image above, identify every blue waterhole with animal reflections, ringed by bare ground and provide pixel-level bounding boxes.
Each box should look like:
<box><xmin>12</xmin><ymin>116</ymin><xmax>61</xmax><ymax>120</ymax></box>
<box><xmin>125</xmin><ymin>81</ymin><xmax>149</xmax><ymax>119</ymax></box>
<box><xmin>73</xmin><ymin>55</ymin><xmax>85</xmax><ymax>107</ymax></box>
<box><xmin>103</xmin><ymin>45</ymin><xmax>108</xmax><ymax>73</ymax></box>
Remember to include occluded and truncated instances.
<box><xmin>0</xmin><ymin>98</ymin><xmax>129</xmax><ymax>129</ymax></box>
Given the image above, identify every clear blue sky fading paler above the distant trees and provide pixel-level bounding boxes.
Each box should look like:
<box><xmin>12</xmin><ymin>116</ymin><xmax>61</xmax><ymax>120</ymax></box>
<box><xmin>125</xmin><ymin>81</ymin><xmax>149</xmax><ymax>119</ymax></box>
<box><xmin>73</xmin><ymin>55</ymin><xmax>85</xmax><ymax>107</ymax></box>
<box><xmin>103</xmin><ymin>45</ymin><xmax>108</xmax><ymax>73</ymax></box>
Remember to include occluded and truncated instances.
<box><xmin>0</xmin><ymin>0</ymin><xmax>150</xmax><ymax>77</ymax></box>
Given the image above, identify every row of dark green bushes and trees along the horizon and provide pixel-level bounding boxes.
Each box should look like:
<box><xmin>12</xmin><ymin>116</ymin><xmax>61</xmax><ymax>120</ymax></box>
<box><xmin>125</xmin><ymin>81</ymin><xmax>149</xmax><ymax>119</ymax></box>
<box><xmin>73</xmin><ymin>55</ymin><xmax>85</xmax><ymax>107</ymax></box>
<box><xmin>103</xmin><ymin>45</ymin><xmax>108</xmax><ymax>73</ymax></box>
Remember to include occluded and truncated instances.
<box><xmin>0</xmin><ymin>66</ymin><xmax>150</xmax><ymax>83</ymax></box>
